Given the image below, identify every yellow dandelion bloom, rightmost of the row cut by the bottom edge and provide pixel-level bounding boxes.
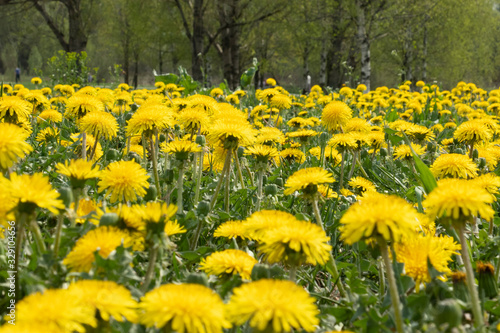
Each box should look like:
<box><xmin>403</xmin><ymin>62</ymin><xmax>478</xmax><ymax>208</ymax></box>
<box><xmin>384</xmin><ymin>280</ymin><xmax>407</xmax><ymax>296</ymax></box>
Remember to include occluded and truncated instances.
<box><xmin>227</xmin><ymin>279</ymin><xmax>319</xmax><ymax>333</ymax></box>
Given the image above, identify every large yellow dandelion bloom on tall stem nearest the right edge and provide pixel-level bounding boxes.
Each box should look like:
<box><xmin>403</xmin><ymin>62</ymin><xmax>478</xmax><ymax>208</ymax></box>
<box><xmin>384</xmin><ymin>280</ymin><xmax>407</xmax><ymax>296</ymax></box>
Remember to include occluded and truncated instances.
<box><xmin>422</xmin><ymin>179</ymin><xmax>495</xmax><ymax>221</ymax></box>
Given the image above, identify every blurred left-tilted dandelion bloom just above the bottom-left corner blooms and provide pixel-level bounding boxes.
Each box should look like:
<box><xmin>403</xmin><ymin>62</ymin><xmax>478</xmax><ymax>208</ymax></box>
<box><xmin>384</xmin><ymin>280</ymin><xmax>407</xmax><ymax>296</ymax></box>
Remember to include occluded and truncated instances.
<box><xmin>63</xmin><ymin>226</ymin><xmax>132</xmax><ymax>272</ymax></box>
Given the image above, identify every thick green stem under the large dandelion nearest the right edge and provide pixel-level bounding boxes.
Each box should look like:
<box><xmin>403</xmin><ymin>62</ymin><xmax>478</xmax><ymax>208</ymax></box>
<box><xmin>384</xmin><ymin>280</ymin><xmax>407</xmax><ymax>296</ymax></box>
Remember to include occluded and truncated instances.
<box><xmin>455</xmin><ymin>222</ymin><xmax>484</xmax><ymax>332</ymax></box>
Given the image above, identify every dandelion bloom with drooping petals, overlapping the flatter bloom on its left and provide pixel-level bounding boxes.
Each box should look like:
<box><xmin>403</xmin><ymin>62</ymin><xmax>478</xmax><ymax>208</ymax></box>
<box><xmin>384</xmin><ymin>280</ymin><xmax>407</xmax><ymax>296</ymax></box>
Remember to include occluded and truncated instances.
<box><xmin>259</xmin><ymin>219</ymin><xmax>332</xmax><ymax>266</ymax></box>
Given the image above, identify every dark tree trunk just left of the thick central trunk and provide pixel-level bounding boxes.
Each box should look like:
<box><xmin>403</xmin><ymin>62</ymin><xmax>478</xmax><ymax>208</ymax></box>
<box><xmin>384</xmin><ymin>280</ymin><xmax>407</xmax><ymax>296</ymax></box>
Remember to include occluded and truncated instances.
<box><xmin>191</xmin><ymin>0</ymin><xmax>204</xmax><ymax>82</ymax></box>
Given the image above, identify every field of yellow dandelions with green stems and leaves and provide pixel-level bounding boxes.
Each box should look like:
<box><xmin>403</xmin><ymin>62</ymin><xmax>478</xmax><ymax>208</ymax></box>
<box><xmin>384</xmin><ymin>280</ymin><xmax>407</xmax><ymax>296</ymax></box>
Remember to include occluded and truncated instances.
<box><xmin>0</xmin><ymin>78</ymin><xmax>500</xmax><ymax>333</ymax></box>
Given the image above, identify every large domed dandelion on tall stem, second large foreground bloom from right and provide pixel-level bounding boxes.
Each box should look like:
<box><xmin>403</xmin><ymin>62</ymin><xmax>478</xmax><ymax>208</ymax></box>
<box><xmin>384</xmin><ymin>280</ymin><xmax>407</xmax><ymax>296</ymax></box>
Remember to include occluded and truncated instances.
<box><xmin>340</xmin><ymin>192</ymin><xmax>419</xmax><ymax>244</ymax></box>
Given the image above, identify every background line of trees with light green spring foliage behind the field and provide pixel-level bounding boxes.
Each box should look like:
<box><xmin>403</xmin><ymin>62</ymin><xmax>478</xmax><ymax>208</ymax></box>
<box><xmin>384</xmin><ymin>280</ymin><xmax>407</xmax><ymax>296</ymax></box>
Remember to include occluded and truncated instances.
<box><xmin>0</xmin><ymin>0</ymin><xmax>500</xmax><ymax>90</ymax></box>
